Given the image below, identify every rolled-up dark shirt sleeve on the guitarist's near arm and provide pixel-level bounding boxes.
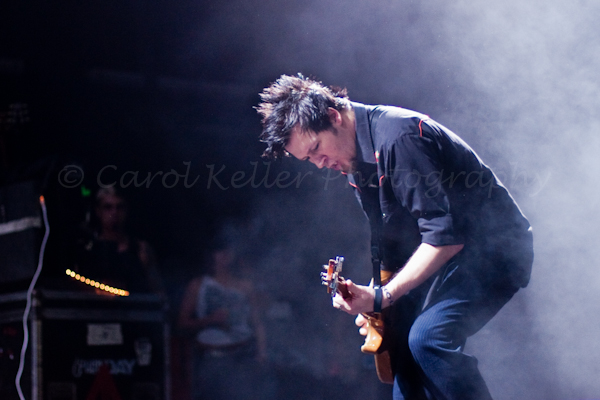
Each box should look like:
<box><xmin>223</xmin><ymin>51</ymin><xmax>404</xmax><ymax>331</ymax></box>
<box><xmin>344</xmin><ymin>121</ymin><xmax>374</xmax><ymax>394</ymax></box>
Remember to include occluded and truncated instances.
<box><xmin>384</xmin><ymin>134</ymin><xmax>464</xmax><ymax>246</ymax></box>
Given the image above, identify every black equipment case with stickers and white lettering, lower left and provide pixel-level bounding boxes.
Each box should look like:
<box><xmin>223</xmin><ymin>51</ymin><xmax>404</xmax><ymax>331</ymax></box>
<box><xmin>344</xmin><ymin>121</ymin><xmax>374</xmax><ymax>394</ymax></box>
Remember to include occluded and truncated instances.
<box><xmin>0</xmin><ymin>289</ymin><xmax>170</xmax><ymax>400</ymax></box>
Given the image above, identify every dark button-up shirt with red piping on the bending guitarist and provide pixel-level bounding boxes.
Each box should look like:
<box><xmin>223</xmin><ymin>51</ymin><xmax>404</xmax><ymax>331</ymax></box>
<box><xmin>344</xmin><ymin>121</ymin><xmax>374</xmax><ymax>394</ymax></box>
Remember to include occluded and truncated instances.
<box><xmin>349</xmin><ymin>102</ymin><xmax>531</xmax><ymax>285</ymax></box>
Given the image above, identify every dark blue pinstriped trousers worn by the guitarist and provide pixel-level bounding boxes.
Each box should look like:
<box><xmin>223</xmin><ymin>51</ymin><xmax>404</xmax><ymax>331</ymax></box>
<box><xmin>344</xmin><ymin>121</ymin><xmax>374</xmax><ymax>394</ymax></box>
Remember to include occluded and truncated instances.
<box><xmin>390</xmin><ymin>258</ymin><xmax>519</xmax><ymax>400</ymax></box>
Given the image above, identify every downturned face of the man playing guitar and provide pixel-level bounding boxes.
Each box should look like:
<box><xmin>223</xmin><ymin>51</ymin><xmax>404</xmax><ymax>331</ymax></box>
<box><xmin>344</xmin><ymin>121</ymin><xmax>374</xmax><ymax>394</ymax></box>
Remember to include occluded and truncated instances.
<box><xmin>285</xmin><ymin>125</ymin><xmax>356</xmax><ymax>173</ymax></box>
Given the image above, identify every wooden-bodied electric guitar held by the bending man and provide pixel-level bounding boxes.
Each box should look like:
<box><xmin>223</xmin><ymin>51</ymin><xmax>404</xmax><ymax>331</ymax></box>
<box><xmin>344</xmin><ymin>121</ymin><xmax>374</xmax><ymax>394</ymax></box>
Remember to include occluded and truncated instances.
<box><xmin>321</xmin><ymin>256</ymin><xmax>394</xmax><ymax>384</ymax></box>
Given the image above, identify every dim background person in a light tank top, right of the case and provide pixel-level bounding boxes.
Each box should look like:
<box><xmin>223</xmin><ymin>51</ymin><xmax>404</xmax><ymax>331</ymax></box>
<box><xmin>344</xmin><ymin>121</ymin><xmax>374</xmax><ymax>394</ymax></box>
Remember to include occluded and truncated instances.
<box><xmin>178</xmin><ymin>248</ymin><xmax>266</xmax><ymax>400</ymax></box>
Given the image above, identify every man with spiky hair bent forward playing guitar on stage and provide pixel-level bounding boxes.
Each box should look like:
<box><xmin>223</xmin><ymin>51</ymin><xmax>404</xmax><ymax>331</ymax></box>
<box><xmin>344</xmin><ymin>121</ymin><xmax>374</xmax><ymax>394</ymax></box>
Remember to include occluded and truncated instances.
<box><xmin>257</xmin><ymin>75</ymin><xmax>533</xmax><ymax>400</ymax></box>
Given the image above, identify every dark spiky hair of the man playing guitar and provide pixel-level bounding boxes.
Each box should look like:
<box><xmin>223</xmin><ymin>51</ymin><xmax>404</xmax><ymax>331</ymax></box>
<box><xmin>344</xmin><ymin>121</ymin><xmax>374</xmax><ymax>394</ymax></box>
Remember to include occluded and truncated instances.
<box><xmin>255</xmin><ymin>74</ymin><xmax>348</xmax><ymax>158</ymax></box>
